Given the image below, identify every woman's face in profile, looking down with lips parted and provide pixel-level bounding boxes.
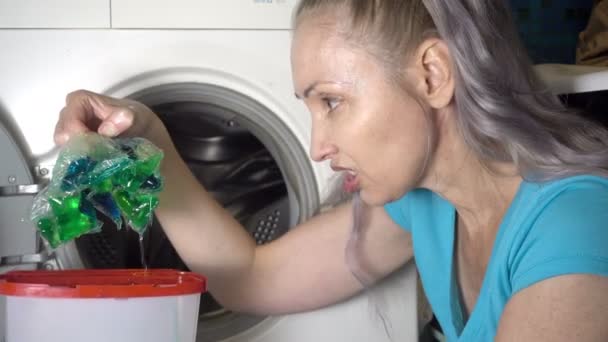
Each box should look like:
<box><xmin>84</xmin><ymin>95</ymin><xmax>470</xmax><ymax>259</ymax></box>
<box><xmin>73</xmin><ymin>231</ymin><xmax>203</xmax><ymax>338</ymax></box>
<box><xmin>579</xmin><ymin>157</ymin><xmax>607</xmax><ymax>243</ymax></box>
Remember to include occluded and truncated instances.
<box><xmin>291</xmin><ymin>17</ymin><xmax>432</xmax><ymax>205</ymax></box>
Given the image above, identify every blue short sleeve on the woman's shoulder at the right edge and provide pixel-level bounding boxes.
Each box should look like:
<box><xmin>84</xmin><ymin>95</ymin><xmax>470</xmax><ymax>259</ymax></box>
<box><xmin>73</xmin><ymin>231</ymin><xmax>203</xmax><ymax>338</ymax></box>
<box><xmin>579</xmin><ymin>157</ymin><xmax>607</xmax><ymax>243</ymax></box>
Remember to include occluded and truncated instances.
<box><xmin>511</xmin><ymin>183</ymin><xmax>608</xmax><ymax>293</ymax></box>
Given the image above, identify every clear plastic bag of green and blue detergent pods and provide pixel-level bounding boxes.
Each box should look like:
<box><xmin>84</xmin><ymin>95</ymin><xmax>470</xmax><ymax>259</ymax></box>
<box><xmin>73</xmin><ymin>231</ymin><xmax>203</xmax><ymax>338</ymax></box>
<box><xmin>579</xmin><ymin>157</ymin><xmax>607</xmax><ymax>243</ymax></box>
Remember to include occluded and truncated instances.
<box><xmin>31</xmin><ymin>133</ymin><xmax>163</xmax><ymax>248</ymax></box>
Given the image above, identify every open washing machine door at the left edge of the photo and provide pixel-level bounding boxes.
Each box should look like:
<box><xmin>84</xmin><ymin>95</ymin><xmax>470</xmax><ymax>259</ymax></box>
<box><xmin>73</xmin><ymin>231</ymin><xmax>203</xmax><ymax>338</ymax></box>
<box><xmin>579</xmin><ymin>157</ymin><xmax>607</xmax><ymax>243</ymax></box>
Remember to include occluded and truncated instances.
<box><xmin>0</xmin><ymin>123</ymin><xmax>46</xmax><ymax>340</ymax></box>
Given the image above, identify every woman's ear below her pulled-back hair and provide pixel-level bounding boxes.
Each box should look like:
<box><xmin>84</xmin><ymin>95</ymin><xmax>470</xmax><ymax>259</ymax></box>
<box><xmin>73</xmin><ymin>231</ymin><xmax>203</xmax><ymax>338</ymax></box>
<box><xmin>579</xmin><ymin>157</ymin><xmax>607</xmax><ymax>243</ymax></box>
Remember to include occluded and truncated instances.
<box><xmin>410</xmin><ymin>38</ymin><xmax>454</xmax><ymax>109</ymax></box>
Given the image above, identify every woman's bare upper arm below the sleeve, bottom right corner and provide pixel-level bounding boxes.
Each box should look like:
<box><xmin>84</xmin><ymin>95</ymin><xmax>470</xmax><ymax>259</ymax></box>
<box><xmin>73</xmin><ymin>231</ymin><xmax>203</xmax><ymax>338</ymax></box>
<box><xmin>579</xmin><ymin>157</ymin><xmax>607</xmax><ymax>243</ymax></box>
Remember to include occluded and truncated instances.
<box><xmin>496</xmin><ymin>274</ymin><xmax>608</xmax><ymax>342</ymax></box>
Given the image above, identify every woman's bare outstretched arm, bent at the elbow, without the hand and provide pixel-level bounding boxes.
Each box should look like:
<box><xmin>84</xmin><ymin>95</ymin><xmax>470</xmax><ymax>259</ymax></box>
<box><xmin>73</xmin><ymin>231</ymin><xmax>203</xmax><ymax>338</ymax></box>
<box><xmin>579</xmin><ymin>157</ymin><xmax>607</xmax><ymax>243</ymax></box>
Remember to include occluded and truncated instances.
<box><xmin>157</xmin><ymin>133</ymin><xmax>413</xmax><ymax>314</ymax></box>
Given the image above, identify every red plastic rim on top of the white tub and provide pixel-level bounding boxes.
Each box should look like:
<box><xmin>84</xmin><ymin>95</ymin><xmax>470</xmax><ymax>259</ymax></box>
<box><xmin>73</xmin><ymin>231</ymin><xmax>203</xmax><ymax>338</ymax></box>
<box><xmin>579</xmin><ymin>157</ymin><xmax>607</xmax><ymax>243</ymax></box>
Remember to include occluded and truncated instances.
<box><xmin>0</xmin><ymin>269</ymin><xmax>206</xmax><ymax>298</ymax></box>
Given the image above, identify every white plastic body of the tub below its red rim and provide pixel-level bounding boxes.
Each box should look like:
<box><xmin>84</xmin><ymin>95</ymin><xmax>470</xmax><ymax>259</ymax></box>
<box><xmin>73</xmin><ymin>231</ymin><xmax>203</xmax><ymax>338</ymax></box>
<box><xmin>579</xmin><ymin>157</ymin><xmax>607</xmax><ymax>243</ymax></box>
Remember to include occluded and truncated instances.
<box><xmin>0</xmin><ymin>272</ymin><xmax>207</xmax><ymax>342</ymax></box>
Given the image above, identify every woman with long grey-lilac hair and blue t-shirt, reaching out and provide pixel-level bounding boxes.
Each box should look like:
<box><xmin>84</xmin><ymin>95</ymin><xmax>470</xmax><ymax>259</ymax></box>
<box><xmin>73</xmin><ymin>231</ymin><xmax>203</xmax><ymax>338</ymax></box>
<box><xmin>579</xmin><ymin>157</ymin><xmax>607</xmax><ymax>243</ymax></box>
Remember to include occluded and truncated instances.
<box><xmin>55</xmin><ymin>0</ymin><xmax>608</xmax><ymax>341</ymax></box>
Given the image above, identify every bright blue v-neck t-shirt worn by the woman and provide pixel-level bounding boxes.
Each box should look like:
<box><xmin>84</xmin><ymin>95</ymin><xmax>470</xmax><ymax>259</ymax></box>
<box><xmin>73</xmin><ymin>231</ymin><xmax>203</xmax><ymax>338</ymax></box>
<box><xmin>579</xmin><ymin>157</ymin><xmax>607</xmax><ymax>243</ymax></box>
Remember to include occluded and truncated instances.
<box><xmin>385</xmin><ymin>176</ymin><xmax>608</xmax><ymax>341</ymax></box>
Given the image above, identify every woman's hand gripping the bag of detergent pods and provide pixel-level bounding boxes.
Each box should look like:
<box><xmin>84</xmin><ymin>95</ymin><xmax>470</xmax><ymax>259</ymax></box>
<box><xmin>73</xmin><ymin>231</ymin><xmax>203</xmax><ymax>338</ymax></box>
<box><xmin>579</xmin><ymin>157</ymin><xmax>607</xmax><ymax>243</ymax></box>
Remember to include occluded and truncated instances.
<box><xmin>54</xmin><ymin>90</ymin><xmax>162</xmax><ymax>145</ymax></box>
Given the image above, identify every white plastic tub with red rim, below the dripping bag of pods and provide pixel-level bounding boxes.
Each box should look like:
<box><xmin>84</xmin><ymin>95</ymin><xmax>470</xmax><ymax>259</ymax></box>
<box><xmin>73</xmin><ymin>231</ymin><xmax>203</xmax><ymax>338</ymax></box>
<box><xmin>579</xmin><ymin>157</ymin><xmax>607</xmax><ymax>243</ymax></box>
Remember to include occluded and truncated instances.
<box><xmin>0</xmin><ymin>270</ymin><xmax>206</xmax><ymax>342</ymax></box>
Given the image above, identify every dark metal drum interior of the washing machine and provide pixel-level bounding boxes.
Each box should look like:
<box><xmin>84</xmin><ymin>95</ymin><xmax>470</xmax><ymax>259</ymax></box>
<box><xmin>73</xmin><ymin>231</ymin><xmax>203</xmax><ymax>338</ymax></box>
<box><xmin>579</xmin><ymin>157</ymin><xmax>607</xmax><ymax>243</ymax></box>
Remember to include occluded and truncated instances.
<box><xmin>76</xmin><ymin>103</ymin><xmax>290</xmax><ymax>316</ymax></box>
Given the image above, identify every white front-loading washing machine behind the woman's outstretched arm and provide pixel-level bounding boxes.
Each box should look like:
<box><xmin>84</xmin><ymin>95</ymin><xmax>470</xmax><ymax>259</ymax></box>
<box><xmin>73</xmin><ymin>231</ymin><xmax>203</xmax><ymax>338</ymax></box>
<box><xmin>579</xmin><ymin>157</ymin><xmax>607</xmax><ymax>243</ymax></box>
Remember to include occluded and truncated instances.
<box><xmin>0</xmin><ymin>0</ymin><xmax>418</xmax><ymax>342</ymax></box>
